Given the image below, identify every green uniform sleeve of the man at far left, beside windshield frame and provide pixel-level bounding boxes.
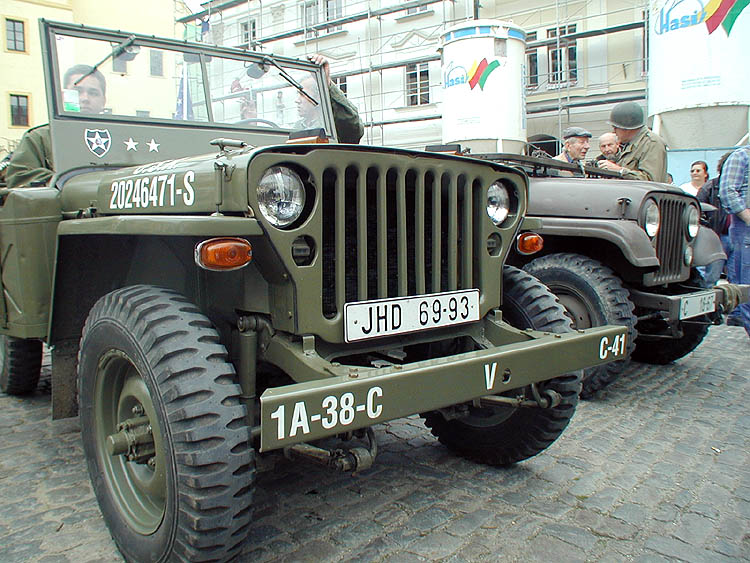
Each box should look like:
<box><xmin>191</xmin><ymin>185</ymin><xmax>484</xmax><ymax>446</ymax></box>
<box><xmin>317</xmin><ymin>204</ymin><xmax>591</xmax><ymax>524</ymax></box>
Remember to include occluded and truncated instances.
<box><xmin>6</xmin><ymin>125</ymin><xmax>55</xmax><ymax>188</ymax></box>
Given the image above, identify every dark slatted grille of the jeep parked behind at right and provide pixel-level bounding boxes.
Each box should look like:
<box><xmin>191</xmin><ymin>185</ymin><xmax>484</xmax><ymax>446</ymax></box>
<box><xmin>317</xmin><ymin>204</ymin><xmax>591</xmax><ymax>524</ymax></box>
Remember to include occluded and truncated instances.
<box><xmin>647</xmin><ymin>194</ymin><xmax>688</xmax><ymax>285</ymax></box>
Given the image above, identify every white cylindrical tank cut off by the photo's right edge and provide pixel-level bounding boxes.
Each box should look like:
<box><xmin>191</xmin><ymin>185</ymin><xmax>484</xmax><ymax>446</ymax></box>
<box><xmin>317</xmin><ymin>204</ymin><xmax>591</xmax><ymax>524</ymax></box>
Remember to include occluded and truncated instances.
<box><xmin>648</xmin><ymin>0</ymin><xmax>750</xmax><ymax>149</ymax></box>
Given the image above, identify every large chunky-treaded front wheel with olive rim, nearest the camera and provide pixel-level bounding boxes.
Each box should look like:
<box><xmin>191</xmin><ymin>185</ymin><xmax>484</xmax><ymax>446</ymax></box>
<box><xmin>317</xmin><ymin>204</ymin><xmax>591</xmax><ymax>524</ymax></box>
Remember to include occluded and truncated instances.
<box><xmin>78</xmin><ymin>285</ymin><xmax>255</xmax><ymax>561</ymax></box>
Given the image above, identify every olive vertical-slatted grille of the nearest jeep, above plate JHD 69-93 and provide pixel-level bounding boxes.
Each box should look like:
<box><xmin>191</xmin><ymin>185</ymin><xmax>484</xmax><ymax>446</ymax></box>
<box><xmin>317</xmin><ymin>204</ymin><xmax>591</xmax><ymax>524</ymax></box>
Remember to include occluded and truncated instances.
<box><xmin>321</xmin><ymin>165</ymin><xmax>484</xmax><ymax>318</ymax></box>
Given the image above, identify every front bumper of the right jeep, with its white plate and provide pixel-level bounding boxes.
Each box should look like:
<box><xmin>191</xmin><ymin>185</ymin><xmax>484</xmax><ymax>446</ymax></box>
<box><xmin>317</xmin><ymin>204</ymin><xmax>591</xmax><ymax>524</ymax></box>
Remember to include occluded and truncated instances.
<box><xmin>630</xmin><ymin>283</ymin><xmax>750</xmax><ymax>322</ymax></box>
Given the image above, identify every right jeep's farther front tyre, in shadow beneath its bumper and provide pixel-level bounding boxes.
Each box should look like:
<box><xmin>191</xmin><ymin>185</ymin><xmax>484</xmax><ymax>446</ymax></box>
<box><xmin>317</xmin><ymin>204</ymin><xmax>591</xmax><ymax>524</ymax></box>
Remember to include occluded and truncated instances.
<box><xmin>633</xmin><ymin>316</ymin><xmax>711</xmax><ymax>365</ymax></box>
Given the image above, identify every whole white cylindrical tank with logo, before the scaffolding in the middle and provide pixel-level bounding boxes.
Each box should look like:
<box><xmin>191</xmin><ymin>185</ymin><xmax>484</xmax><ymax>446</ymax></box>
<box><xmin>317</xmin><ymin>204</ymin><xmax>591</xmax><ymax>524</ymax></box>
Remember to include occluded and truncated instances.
<box><xmin>440</xmin><ymin>20</ymin><xmax>526</xmax><ymax>154</ymax></box>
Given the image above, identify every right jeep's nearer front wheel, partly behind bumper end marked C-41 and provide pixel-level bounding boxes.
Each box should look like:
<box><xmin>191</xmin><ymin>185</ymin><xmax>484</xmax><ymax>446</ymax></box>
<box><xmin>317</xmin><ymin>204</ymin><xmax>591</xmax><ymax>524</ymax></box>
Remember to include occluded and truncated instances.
<box><xmin>524</xmin><ymin>254</ymin><xmax>638</xmax><ymax>399</ymax></box>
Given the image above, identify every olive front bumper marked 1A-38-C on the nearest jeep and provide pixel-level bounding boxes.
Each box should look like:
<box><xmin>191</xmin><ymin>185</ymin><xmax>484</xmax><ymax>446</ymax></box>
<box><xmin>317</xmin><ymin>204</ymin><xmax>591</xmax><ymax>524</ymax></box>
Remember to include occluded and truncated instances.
<box><xmin>260</xmin><ymin>320</ymin><xmax>627</xmax><ymax>452</ymax></box>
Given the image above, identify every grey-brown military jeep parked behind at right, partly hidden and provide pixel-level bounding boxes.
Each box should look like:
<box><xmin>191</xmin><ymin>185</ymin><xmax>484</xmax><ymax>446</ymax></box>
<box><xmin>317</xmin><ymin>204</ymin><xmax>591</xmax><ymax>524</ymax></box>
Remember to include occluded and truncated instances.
<box><xmin>479</xmin><ymin>154</ymin><xmax>750</xmax><ymax>398</ymax></box>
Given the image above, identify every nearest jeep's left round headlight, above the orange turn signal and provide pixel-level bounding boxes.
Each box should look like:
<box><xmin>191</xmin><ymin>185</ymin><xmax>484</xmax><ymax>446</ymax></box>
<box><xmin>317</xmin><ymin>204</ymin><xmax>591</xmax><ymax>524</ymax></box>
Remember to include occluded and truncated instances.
<box><xmin>258</xmin><ymin>166</ymin><xmax>305</xmax><ymax>228</ymax></box>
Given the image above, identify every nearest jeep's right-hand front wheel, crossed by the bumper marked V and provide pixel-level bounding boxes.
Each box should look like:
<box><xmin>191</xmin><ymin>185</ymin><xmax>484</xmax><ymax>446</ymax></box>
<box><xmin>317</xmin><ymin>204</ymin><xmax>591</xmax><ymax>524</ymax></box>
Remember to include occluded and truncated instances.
<box><xmin>424</xmin><ymin>266</ymin><xmax>581</xmax><ymax>465</ymax></box>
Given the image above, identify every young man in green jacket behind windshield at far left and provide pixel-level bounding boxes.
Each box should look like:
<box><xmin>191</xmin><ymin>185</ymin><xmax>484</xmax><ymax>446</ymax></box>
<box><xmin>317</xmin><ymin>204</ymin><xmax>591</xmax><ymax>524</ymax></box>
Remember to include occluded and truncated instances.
<box><xmin>6</xmin><ymin>65</ymin><xmax>107</xmax><ymax>188</ymax></box>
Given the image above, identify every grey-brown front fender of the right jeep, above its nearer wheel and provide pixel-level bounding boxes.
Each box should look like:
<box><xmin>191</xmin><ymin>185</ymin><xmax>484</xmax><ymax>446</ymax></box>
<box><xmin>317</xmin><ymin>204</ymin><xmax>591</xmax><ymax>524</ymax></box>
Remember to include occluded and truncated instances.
<box><xmin>537</xmin><ymin>217</ymin><xmax>660</xmax><ymax>268</ymax></box>
